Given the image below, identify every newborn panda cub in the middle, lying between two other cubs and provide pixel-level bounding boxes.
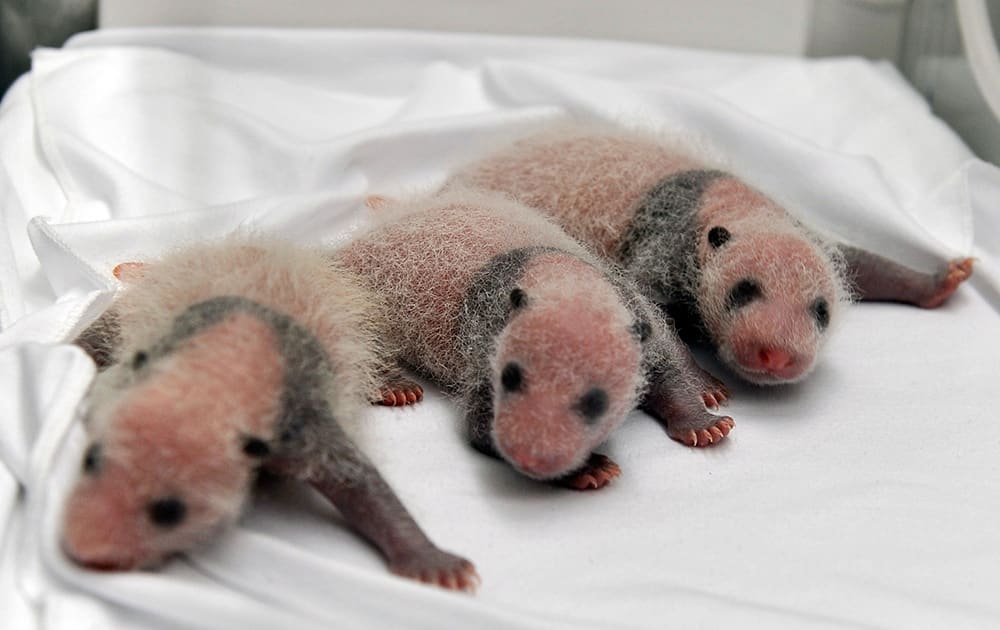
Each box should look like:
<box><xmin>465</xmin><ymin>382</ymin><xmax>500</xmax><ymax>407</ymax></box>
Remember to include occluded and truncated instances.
<box><xmin>336</xmin><ymin>191</ymin><xmax>733</xmax><ymax>489</ymax></box>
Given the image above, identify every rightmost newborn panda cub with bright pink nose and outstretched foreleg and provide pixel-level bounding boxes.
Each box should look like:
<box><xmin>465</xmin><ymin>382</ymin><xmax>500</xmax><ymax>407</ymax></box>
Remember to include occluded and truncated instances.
<box><xmin>448</xmin><ymin>123</ymin><xmax>972</xmax><ymax>384</ymax></box>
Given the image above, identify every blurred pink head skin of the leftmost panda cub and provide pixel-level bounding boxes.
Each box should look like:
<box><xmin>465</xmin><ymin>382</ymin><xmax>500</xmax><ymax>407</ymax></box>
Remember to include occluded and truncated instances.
<box><xmin>63</xmin><ymin>316</ymin><xmax>282</xmax><ymax>570</ymax></box>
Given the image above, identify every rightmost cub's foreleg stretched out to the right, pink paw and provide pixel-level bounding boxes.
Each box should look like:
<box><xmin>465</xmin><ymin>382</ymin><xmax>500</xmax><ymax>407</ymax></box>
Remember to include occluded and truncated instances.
<box><xmin>840</xmin><ymin>245</ymin><xmax>973</xmax><ymax>308</ymax></box>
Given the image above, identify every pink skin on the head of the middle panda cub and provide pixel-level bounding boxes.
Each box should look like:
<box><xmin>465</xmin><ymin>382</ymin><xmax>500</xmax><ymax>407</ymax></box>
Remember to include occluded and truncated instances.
<box><xmin>493</xmin><ymin>254</ymin><xmax>641</xmax><ymax>488</ymax></box>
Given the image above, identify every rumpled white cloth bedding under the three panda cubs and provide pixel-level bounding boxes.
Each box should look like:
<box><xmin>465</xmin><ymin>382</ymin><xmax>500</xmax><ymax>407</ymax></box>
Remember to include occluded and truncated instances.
<box><xmin>0</xmin><ymin>30</ymin><xmax>1000</xmax><ymax>630</ymax></box>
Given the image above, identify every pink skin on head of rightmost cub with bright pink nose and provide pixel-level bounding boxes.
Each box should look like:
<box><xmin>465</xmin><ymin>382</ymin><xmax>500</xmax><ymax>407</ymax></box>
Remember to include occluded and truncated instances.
<box><xmin>697</xmin><ymin>178</ymin><xmax>838</xmax><ymax>384</ymax></box>
